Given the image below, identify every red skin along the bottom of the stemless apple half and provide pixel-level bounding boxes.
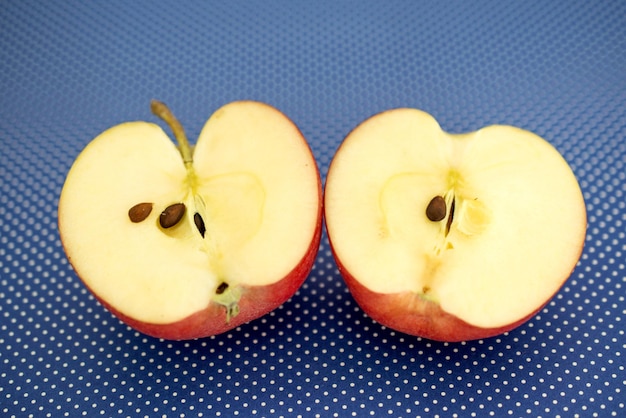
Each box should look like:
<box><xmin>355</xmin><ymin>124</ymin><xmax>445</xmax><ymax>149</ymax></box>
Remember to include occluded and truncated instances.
<box><xmin>329</xmin><ymin>233</ymin><xmax>576</xmax><ymax>342</ymax></box>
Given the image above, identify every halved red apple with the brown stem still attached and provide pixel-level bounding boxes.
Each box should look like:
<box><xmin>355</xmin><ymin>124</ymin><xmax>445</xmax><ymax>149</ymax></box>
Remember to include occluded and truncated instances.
<box><xmin>58</xmin><ymin>101</ymin><xmax>322</xmax><ymax>340</ymax></box>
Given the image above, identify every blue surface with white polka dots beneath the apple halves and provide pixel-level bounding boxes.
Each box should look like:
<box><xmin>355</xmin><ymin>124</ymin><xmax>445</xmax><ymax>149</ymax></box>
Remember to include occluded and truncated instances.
<box><xmin>0</xmin><ymin>0</ymin><xmax>626</xmax><ymax>417</ymax></box>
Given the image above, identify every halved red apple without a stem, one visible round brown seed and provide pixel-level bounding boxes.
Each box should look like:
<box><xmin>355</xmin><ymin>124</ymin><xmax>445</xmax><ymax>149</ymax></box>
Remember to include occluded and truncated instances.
<box><xmin>324</xmin><ymin>108</ymin><xmax>587</xmax><ymax>342</ymax></box>
